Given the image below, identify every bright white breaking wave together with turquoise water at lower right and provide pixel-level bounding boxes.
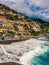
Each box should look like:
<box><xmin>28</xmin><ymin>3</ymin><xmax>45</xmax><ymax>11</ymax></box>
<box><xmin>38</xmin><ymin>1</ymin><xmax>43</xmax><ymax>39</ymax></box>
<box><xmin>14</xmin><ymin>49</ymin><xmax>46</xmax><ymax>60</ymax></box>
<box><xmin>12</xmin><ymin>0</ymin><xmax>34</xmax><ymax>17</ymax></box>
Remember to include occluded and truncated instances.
<box><xmin>20</xmin><ymin>36</ymin><xmax>49</xmax><ymax>65</ymax></box>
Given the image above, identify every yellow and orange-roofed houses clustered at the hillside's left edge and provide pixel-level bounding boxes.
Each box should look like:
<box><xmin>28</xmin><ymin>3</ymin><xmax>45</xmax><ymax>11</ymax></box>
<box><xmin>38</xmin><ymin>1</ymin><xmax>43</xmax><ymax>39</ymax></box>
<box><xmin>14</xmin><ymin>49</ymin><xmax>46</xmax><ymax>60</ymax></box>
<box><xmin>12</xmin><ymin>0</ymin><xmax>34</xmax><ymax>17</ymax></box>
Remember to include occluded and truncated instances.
<box><xmin>0</xmin><ymin>16</ymin><xmax>13</xmax><ymax>36</ymax></box>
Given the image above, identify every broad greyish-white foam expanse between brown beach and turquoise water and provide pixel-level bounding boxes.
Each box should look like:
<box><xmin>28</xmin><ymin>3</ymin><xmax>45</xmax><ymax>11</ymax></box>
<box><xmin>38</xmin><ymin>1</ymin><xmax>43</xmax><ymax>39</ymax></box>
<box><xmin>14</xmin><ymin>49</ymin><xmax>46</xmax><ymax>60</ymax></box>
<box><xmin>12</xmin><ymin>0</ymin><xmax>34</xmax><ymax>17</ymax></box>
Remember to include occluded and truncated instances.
<box><xmin>0</xmin><ymin>38</ymin><xmax>46</xmax><ymax>65</ymax></box>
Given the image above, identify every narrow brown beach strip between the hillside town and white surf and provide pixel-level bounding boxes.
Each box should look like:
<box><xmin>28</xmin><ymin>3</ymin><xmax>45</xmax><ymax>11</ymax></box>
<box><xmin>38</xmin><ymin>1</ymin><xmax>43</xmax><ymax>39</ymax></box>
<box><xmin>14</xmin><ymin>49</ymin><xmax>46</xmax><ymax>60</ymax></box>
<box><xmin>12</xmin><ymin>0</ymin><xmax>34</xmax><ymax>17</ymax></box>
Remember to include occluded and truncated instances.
<box><xmin>0</xmin><ymin>36</ymin><xmax>49</xmax><ymax>44</ymax></box>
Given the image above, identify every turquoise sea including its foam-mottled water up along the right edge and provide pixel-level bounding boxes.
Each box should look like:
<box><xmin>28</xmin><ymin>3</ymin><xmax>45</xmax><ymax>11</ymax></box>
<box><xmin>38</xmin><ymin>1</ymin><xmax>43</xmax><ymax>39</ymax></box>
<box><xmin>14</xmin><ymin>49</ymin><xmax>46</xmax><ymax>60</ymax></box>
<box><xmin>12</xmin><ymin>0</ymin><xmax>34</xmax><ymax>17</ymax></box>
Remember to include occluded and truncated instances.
<box><xmin>28</xmin><ymin>37</ymin><xmax>49</xmax><ymax>65</ymax></box>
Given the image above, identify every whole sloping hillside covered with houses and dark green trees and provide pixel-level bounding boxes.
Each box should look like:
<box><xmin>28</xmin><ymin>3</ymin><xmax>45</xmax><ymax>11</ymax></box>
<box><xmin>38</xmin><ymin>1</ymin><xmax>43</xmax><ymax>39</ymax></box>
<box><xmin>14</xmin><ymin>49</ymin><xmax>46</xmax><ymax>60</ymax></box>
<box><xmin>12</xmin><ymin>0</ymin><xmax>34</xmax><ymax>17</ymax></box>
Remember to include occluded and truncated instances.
<box><xmin>0</xmin><ymin>4</ymin><xmax>49</xmax><ymax>36</ymax></box>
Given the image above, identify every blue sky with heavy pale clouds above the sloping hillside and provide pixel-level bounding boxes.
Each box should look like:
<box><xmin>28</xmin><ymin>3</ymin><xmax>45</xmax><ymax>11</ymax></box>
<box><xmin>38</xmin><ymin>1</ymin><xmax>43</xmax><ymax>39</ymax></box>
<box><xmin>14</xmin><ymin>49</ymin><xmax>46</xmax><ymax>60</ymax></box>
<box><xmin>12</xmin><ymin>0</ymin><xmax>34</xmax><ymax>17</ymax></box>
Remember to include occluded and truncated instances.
<box><xmin>0</xmin><ymin>0</ymin><xmax>49</xmax><ymax>22</ymax></box>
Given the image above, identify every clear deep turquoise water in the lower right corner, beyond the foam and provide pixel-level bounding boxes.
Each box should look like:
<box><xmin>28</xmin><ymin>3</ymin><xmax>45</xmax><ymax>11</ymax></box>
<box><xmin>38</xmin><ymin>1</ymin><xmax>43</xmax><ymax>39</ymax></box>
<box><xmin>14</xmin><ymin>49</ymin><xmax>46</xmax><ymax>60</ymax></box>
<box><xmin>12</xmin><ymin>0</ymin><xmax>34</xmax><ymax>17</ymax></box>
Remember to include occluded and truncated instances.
<box><xmin>30</xmin><ymin>51</ymin><xmax>49</xmax><ymax>65</ymax></box>
